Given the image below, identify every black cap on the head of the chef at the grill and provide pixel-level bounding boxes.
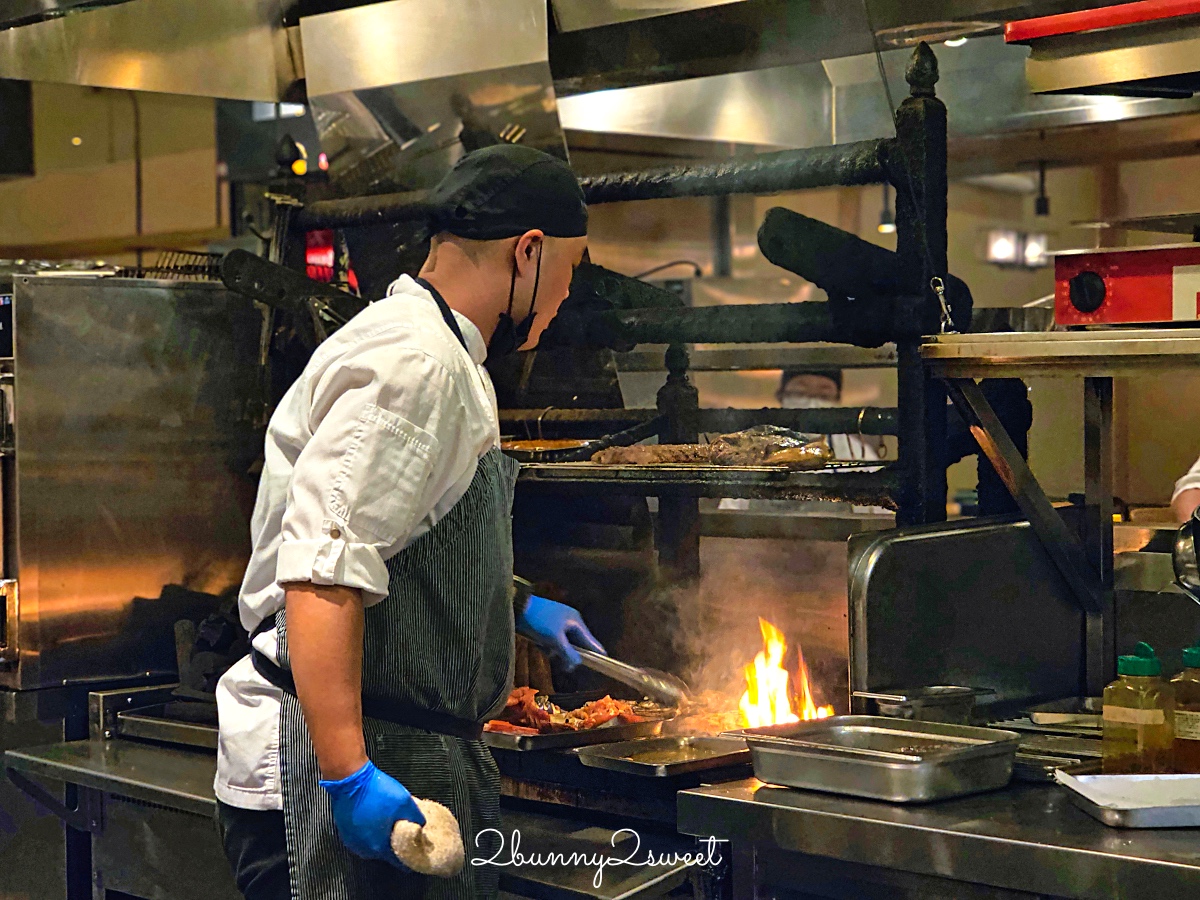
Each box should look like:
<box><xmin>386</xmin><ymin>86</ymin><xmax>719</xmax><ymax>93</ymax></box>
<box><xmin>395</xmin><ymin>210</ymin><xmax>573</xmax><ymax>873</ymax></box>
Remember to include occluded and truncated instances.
<box><xmin>427</xmin><ymin>144</ymin><xmax>588</xmax><ymax>241</ymax></box>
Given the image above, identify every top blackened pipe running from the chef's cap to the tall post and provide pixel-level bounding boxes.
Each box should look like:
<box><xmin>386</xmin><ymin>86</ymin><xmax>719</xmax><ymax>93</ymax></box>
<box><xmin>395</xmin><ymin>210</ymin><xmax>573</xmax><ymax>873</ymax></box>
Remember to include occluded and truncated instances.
<box><xmin>581</xmin><ymin>138</ymin><xmax>895</xmax><ymax>204</ymax></box>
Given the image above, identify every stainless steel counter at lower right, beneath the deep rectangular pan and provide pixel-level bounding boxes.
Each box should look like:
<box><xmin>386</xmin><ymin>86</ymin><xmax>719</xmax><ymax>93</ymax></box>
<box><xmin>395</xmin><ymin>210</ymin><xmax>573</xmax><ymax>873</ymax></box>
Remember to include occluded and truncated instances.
<box><xmin>679</xmin><ymin>779</ymin><xmax>1200</xmax><ymax>900</ymax></box>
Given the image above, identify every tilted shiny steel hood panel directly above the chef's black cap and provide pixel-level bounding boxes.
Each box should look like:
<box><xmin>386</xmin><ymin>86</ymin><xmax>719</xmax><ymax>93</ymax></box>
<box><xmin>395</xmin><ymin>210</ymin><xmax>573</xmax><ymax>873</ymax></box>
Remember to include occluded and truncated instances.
<box><xmin>300</xmin><ymin>0</ymin><xmax>566</xmax><ymax>197</ymax></box>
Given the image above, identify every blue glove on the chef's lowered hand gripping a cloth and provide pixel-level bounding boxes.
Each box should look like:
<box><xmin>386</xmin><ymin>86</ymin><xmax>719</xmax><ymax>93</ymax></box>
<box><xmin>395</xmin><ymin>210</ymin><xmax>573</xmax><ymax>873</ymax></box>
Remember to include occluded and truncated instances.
<box><xmin>320</xmin><ymin>761</ymin><xmax>425</xmax><ymax>871</ymax></box>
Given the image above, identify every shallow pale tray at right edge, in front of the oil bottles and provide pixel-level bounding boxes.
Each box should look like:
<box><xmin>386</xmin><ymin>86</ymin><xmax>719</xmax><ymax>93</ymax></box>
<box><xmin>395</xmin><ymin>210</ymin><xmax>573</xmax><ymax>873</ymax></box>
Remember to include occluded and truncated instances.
<box><xmin>1055</xmin><ymin>772</ymin><xmax>1200</xmax><ymax>828</ymax></box>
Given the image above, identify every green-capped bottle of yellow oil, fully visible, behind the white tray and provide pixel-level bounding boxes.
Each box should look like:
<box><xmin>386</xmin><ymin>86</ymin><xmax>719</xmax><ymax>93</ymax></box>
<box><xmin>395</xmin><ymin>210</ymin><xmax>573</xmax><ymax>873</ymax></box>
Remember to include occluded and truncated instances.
<box><xmin>1103</xmin><ymin>643</ymin><xmax>1175</xmax><ymax>775</ymax></box>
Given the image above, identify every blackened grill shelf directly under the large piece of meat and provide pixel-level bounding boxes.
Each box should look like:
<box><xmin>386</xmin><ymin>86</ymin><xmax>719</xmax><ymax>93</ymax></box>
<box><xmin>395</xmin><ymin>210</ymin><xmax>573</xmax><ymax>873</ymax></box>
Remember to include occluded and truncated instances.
<box><xmin>518</xmin><ymin>462</ymin><xmax>900</xmax><ymax>506</ymax></box>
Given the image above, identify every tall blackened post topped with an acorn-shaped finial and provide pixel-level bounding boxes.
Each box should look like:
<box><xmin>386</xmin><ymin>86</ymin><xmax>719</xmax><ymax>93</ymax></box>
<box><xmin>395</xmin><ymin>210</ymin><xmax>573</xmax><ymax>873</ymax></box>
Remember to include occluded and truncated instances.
<box><xmin>887</xmin><ymin>42</ymin><xmax>947</xmax><ymax>526</ymax></box>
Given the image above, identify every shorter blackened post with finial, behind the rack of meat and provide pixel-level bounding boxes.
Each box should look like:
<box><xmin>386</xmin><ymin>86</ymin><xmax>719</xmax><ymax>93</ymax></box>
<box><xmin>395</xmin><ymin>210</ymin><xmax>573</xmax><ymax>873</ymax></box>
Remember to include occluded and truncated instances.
<box><xmin>658</xmin><ymin>344</ymin><xmax>700</xmax><ymax>578</ymax></box>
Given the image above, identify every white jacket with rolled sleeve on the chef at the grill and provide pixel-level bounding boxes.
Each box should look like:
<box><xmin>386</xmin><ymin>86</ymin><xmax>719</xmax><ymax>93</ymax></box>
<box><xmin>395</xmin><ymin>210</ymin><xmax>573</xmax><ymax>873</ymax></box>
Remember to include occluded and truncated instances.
<box><xmin>215</xmin><ymin>276</ymin><xmax>499</xmax><ymax>810</ymax></box>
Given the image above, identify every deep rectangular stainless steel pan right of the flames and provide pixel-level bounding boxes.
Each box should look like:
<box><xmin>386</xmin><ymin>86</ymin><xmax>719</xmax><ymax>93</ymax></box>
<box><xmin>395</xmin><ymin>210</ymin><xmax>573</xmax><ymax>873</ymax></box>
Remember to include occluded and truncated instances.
<box><xmin>736</xmin><ymin>715</ymin><xmax>1020</xmax><ymax>803</ymax></box>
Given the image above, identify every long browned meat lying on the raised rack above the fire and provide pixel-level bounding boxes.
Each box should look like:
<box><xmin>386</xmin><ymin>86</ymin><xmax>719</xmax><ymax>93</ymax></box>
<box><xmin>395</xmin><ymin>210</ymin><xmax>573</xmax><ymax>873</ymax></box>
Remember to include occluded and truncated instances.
<box><xmin>592</xmin><ymin>425</ymin><xmax>833</xmax><ymax>469</ymax></box>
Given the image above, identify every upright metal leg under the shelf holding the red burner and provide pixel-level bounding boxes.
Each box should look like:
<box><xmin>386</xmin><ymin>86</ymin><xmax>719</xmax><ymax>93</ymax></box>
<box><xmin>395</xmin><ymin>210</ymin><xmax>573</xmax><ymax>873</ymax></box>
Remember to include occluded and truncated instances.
<box><xmin>1084</xmin><ymin>378</ymin><xmax>1117</xmax><ymax>697</ymax></box>
